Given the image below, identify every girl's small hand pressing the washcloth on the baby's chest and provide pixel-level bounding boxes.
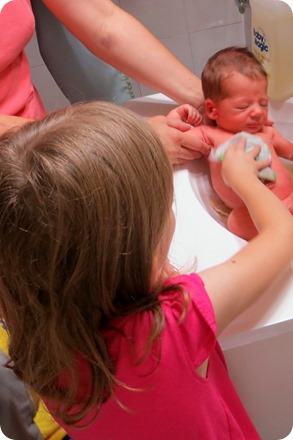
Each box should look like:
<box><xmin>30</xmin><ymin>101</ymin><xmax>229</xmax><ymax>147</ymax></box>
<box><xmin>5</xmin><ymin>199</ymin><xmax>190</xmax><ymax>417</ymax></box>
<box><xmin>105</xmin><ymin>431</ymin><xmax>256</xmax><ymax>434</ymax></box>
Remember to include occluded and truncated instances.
<box><xmin>222</xmin><ymin>138</ymin><xmax>270</xmax><ymax>192</ymax></box>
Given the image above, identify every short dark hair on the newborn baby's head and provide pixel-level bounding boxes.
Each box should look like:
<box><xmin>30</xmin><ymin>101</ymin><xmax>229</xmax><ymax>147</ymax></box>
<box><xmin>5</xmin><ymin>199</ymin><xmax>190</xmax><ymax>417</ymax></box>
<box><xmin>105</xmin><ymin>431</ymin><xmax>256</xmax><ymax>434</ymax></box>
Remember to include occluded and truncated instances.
<box><xmin>201</xmin><ymin>46</ymin><xmax>267</xmax><ymax>101</ymax></box>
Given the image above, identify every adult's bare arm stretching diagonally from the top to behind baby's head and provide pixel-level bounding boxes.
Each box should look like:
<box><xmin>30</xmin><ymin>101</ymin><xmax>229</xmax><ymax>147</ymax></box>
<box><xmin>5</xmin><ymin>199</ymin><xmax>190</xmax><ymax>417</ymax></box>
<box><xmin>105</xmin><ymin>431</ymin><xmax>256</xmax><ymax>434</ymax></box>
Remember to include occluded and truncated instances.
<box><xmin>43</xmin><ymin>0</ymin><xmax>203</xmax><ymax>107</ymax></box>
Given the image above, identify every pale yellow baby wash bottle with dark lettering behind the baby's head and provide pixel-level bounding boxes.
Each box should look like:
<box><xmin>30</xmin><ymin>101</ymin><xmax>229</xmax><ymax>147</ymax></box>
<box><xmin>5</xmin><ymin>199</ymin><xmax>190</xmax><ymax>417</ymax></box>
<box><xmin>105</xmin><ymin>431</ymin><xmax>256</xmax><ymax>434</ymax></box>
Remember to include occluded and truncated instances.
<box><xmin>250</xmin><ymin>0</ymin><xmax>293</xmax><ymax>100</ymax></box>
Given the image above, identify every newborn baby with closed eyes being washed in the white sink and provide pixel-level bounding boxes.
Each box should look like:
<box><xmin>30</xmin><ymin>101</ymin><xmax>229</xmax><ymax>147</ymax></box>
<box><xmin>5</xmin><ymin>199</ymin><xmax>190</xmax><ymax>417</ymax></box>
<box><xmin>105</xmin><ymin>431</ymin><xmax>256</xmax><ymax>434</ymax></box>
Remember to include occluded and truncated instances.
<box><xmin>168</xmin><ymin>47</ymin><xmax>293</xmax><ymax>240</ymax></box>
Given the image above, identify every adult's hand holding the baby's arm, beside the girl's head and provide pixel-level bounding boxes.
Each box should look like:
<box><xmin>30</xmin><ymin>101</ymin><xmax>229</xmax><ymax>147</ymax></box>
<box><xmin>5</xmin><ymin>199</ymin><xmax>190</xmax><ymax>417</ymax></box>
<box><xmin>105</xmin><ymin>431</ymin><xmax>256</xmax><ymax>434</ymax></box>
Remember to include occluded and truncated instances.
<box><xmin>148</xmin><ymin>115</ymin><xmax>210</xmax><ymax>165</ymax></box>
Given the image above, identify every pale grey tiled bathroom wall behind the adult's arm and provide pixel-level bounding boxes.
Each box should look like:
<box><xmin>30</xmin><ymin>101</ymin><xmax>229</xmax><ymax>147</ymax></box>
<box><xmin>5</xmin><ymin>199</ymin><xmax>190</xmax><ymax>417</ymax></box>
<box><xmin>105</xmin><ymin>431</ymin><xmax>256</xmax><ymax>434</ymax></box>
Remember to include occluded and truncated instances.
<box><xmin>27</xmin><ymin>0</ymin><xmax>245</xmax><ymax>111</ymax></box>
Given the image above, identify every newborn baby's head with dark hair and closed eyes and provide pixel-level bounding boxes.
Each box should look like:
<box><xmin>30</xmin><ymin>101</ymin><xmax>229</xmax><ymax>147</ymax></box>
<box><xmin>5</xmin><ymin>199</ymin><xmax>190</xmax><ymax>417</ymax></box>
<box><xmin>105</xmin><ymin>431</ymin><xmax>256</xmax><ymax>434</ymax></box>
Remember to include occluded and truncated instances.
<box><xmin>202</xmin><ymin>47</ymin><xmax>268</xmax><ymax>133</ymax></box>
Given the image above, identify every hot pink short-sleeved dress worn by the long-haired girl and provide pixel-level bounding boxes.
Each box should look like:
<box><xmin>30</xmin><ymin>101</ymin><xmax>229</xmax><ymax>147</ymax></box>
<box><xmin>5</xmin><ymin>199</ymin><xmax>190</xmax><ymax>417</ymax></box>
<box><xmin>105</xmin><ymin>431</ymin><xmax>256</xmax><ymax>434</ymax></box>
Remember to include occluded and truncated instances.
<box><xmin>46</xmin><ymin>274</ymin><xmax>260</xmax><ymax>440</ymax></box>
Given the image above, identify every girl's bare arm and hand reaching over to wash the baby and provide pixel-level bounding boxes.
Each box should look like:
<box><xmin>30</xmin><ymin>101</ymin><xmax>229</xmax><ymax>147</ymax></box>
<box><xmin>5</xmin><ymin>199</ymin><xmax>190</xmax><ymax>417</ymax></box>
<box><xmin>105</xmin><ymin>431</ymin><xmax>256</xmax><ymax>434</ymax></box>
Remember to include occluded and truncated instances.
<box><xmin>200</xmin><ymin>141</ymin><xmax>293</xmax><ymax>334</ymax></box>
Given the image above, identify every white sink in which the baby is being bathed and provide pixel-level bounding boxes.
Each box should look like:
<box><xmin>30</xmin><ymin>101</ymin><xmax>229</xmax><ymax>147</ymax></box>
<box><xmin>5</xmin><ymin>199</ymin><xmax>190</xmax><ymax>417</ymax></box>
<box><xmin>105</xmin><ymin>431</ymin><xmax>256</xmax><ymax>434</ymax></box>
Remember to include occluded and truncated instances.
<box><xmin>126</xmin><ymin>94</ymin><xmax>293</xmax><ymax>440</ymax></box>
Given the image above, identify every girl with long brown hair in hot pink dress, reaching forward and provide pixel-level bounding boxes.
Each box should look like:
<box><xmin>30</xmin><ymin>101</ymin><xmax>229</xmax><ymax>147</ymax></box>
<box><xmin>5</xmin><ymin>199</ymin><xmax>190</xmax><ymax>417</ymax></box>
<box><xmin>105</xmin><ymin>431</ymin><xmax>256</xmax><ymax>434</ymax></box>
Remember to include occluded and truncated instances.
<box><xmin>0</xmin><ymin>102</ymin><xmax>293</xmax><ymax>440</ymax></box>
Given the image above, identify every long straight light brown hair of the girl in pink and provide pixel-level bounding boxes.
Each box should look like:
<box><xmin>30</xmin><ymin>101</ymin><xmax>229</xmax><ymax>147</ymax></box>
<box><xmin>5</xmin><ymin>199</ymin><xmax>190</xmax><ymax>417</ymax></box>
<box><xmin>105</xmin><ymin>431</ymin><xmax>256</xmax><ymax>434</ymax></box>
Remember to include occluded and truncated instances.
<box><xmin>0</xmin><ymin>102</ymin><xmax>173</xmax><ymax>424</ymax></box>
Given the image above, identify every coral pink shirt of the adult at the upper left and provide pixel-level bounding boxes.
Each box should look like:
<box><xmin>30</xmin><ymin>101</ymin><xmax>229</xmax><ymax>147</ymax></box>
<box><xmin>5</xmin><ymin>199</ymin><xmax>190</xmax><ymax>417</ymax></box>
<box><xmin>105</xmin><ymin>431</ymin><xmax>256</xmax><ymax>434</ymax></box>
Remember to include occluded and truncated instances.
<box><xmin>0</xmin><ymin>0</ymin><xmax>45</xmax><ymax>119</ymax></box>
